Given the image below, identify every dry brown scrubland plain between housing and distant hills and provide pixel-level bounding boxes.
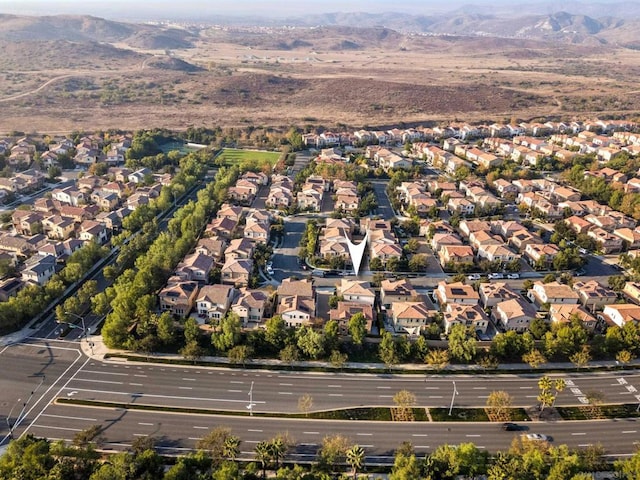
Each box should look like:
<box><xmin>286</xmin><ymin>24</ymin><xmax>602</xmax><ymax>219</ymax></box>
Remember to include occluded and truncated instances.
<box><xmin>0</xmin><ymin>34</ymin><xmax>640</xmax><ymax>133</ymax></box>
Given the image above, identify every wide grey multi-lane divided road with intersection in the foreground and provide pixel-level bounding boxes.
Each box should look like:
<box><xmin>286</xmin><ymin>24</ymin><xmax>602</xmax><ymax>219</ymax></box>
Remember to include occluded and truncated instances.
<box><xmin>0</xmin><ymin>340</ymin><xmax>640</xmax><ymax>463</ymax></box>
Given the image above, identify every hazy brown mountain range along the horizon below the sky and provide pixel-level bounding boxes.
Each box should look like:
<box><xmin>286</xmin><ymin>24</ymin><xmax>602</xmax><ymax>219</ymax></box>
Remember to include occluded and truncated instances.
<box><xmin>0</xmin><ymin>7</ymin><xmax>640</xmax><ymax>49</ymax></box>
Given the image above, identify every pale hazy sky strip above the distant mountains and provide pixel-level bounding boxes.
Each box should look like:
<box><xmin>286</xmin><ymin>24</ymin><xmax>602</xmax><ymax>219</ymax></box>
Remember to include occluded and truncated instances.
<box><xmin>0</xmin><ymin>0</ymin><xmax>617</xmax><ymax>20</ymax></box>
